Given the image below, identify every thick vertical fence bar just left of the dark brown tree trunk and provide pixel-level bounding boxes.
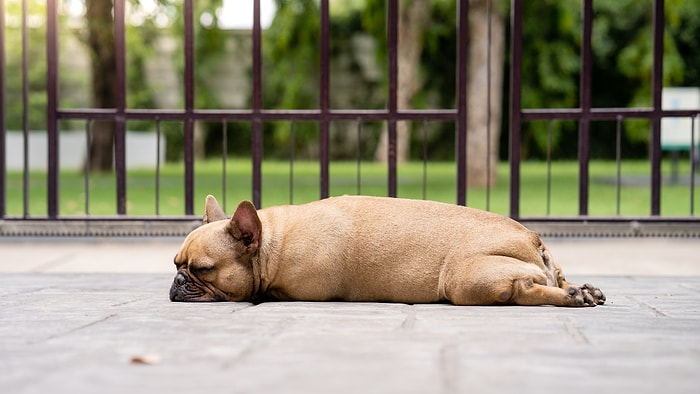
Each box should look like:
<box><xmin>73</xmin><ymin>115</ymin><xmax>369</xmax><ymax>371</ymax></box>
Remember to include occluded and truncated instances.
<box><xmin>46</xmin><ymin>0</ymin><xmax>58</xmax><ymax>219</ymax></box>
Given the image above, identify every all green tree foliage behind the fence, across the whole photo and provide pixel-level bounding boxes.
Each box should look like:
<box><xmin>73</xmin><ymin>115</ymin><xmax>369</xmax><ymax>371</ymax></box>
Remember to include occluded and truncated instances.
<box><xmin>4</xmin><ymin>0</ymin><xmax>700</xmax><ymax>163</ymax></box>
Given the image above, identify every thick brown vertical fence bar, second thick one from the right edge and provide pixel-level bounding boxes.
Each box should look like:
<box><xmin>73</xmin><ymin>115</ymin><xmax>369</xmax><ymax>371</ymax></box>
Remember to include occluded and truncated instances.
<box><xmin>578</xmin><ymin>0</ymin><xmax>593</xmax><ymax>216</ymax></box>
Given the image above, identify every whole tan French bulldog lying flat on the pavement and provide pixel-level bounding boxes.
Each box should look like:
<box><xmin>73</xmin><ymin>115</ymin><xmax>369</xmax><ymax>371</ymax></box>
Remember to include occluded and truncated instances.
<box><xmin>170</xmin><ymin>196</ymin><xmax>605</xmax><ymax>306</ymax></box>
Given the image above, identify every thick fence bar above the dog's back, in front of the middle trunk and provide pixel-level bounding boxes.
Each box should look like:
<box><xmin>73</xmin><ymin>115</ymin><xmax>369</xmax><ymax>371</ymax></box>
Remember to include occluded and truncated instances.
<box><xmin>387</xmin><ymin>0</ymin><xmax>399</xmax><ymax>197</ymax></box>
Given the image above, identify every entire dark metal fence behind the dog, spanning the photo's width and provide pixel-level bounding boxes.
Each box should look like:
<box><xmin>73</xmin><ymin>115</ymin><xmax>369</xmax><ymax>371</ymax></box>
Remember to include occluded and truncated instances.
<box><xmin>0</xmin><ymin>0</ymin><xmax>700</xmax><ymax>236</ymax></box>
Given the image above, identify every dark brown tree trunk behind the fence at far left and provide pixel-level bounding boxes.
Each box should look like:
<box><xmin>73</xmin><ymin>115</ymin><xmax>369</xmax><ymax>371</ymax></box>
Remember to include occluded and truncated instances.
<box><xmin>85</xmin><ymin>0</ymin><xmax>117</xmax><ymax>172</ymax></box>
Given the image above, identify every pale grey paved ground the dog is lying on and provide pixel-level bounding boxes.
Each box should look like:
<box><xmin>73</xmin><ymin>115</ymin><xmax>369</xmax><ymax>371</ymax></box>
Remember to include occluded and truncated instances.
<box><xmin>0</xmin><ymin>238</ymin><xmax>700</xmax><ymax>394</ymax></box>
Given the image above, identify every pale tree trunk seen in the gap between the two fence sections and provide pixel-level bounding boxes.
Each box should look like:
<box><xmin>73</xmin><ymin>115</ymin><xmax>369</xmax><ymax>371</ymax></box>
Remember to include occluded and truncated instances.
<box><xmin>467</xmin><ymin>0</ymin><xmax>505</xmax><ymax>187</ymax></box>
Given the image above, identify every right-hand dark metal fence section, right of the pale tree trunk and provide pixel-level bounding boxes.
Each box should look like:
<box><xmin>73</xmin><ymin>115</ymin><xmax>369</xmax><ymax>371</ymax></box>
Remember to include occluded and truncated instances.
<box><xmin>510</xmin><ymin>0</ymin><xmax>700</xmax><ymax>236</ymax></box>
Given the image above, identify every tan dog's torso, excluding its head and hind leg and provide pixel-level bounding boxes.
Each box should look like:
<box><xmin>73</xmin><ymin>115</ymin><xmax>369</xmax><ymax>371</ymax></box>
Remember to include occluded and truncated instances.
<box><xmin>258</xmin><ymin>196</ymin><xmax>544</xmax><ymax>303</ymax></box>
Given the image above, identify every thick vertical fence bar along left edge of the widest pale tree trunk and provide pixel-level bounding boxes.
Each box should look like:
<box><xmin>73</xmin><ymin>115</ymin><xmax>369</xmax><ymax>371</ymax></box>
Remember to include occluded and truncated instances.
<box><xmin>456</xmin><ymin>0</ymin><xmax>469</xmax><ymax>205</ymax></box>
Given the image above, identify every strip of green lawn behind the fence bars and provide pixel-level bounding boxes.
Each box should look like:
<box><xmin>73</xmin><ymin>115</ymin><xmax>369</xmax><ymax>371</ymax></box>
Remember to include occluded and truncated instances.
<box><xmin>6</xmin><ymin>159</ymin><xmax>700</xmax><ymax>217</ymax></box>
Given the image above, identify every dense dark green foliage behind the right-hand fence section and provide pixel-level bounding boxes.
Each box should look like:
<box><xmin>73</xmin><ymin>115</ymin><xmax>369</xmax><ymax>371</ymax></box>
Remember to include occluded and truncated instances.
<box><xmin>522</xmin><ymin>0</ymin><xmax>700</xmax><ymax>158</ymax></box>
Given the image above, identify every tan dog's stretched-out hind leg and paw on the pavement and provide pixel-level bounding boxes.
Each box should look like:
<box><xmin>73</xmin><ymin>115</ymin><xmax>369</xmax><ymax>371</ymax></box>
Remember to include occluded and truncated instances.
<box><xmin>441</xmin><ymin>256</ymin><xmax>605</xmax><ymax>306</ymax></box>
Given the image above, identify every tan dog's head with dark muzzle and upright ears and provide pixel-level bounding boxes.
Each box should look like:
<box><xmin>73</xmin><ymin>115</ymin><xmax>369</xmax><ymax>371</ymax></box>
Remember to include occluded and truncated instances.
<box><xmin>170</xmin><ymin>196</ymin><xmax>262</xmax><ymax>302</ymax></box>
